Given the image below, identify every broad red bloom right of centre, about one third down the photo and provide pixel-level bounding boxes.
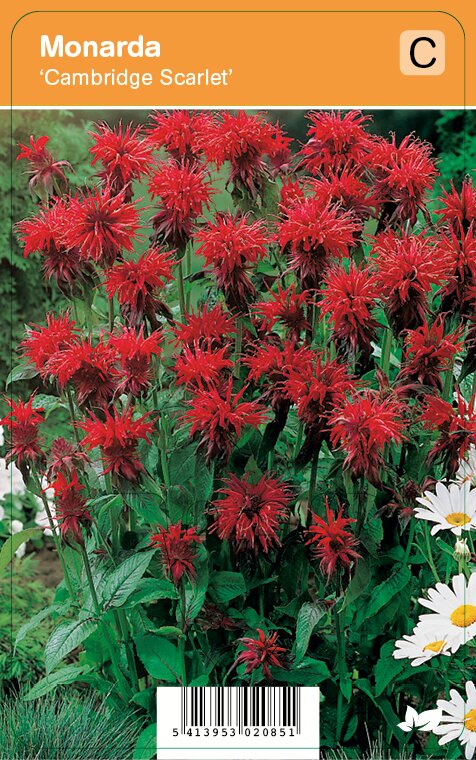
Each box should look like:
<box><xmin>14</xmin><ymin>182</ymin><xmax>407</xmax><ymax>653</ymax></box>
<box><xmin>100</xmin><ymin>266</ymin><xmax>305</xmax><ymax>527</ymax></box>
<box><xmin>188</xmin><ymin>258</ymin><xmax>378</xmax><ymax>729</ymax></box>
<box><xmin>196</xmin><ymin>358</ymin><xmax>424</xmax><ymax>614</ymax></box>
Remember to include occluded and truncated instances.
<box><xmin>278</xmin><ymin>198</ymin><xmax>360</xmax><ymax>290</ymax></box>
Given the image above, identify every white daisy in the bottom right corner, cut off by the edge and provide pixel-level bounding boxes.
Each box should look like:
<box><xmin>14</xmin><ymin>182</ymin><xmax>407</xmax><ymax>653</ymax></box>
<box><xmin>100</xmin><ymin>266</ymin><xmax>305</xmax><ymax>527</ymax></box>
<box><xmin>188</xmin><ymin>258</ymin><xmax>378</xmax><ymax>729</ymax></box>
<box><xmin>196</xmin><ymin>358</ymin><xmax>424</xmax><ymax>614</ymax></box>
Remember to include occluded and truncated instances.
<box><xmin>433</xmin><ymin>681</ymin><xmax>476</xmax><ymax>760</ymax></box>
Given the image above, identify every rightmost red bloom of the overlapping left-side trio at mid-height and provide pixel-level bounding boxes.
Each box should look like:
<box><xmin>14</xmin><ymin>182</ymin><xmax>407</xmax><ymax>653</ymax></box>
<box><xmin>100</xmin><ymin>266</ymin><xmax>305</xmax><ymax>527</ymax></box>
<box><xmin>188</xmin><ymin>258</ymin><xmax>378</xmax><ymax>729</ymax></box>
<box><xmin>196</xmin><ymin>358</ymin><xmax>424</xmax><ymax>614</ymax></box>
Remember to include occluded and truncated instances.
<box><xmin>109</xmin><ymin>327</ymin><xmax>162</xmax><ymax>396</ymax></box>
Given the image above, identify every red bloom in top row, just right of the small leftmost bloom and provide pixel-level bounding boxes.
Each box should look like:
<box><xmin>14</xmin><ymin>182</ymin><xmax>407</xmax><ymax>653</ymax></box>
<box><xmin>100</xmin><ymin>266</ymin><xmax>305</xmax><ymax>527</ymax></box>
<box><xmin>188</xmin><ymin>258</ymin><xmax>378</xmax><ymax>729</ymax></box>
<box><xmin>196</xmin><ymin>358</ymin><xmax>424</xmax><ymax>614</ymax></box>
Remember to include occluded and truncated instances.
<box><xmin>89</xmin><ymin>121</ymin><xmax>152</xmax><ymax>201</ymax></box>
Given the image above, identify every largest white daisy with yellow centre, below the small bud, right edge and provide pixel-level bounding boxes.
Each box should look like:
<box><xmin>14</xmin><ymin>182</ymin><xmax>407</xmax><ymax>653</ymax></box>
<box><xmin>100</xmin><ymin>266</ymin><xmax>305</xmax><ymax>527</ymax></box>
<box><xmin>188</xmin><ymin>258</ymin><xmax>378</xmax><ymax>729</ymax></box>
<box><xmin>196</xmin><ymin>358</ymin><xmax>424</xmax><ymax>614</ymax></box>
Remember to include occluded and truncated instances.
<box><xmin>418</xmin><ymin>573</ymin><xmax>476</xmax><ymax>652</ymax></box>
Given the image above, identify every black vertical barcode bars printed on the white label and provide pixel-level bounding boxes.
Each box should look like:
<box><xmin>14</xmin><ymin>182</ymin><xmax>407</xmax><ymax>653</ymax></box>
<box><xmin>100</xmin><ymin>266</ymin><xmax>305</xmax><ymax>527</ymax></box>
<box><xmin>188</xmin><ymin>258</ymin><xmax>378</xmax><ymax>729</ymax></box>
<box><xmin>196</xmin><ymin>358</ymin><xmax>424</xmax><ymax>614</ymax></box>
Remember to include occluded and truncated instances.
<box><xmin>181</xmin><ymin>686</ymin><xmax>301</xmax><ymax>734</ymax></box>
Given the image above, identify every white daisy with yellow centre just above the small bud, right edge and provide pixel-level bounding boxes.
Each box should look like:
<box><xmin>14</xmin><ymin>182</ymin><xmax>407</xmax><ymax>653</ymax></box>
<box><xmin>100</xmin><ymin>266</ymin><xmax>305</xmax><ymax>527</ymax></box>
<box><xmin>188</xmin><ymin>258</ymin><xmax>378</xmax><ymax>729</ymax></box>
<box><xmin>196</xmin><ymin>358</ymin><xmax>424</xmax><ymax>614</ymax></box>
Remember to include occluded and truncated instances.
<box><xmin>415</xmin><ymin>482</ymin><xmax>476</xmax><ymax>536</ymax></box>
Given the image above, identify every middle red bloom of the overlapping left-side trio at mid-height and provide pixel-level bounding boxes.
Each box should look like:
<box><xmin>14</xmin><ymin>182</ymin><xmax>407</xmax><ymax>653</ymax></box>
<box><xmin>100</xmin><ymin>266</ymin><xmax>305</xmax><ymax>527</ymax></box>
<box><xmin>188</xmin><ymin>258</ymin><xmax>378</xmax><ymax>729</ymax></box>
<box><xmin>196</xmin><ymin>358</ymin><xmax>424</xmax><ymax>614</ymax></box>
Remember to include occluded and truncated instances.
<box><xmin>48</xmin><ymin>338</ymin><xmax>119</xmax><ymax>406</ymax></box>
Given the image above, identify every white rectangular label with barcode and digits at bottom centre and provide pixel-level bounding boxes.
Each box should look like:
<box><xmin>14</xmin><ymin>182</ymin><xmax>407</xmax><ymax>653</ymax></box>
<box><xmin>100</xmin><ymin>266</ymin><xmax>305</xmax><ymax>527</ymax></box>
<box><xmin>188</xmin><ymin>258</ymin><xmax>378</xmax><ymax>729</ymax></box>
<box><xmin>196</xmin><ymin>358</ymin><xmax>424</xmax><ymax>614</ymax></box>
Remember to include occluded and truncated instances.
<box><xmin>157</xmin><ymin>686</ymin><xmax>319</xmax><ymax>760</ymax></box>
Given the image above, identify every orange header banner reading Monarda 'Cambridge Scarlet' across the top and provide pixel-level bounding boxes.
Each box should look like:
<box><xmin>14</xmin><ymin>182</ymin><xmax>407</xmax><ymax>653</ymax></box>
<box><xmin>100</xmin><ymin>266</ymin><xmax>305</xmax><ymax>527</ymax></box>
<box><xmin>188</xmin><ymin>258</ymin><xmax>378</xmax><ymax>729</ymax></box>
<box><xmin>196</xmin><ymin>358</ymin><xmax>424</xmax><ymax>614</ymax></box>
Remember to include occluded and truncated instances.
<box><xmin>2</xmin><ymin>0</ymin><xmax>476</xmax><ymax>108</ymax></box>
